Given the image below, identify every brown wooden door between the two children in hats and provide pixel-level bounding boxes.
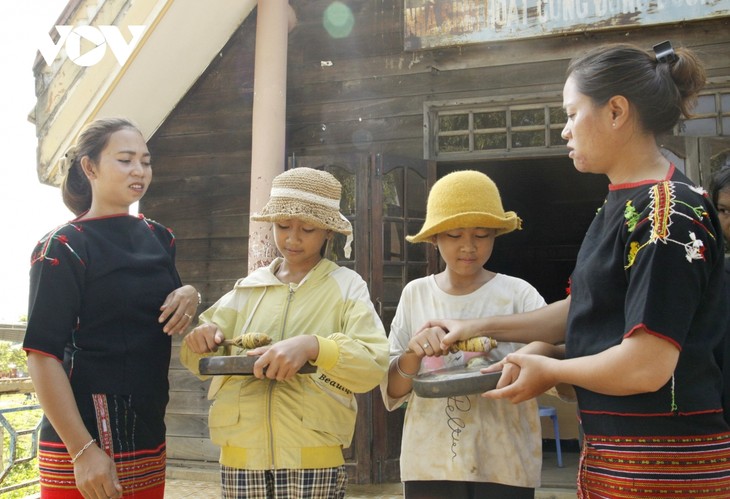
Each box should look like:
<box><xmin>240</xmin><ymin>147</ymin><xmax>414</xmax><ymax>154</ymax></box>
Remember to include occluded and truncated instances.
<box><xmin>288</xmin><ymin>153</ymin><xmax>436</xmax><ymax>483</ymax></box>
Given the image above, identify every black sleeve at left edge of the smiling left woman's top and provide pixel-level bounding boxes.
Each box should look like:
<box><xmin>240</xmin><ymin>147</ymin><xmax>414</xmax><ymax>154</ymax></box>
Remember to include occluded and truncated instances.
<box><xmin>23</xmin><ymin>224</ymin><xmax>86</xmax><ymax>360</ymax></box>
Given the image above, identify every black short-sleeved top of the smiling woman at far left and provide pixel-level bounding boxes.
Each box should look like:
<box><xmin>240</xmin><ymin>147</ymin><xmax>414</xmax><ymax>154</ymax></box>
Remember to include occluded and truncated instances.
<box><xmin>23</xmin><ymin>214</ymin><xmax>181</xmax><ymax>398</ymax></box>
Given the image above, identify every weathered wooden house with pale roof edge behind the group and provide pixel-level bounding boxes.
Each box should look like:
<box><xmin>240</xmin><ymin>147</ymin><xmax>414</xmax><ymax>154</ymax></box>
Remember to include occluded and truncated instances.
<box><xmin>29</xmin><ymin>0</ymin><xmax>730</xmax><ymax>483</ymax></box>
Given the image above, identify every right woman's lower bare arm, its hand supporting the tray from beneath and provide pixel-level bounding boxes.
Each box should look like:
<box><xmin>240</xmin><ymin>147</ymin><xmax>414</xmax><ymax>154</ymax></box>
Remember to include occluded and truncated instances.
<box><xmin>484</xmin><ymin>329</ymin><xmax>679</xmax><ymax>403</ymax></box>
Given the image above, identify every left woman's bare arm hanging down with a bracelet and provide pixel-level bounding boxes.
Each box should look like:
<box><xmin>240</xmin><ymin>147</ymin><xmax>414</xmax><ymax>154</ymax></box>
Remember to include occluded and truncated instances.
<box><xmin>28</xmin><ymin>352</ymin><xmax>122</xmax><ymax>499</ymax></box>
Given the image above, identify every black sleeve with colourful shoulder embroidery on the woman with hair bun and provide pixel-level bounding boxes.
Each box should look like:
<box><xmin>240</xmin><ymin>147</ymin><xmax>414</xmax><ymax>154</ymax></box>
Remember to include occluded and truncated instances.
<box><xmin>624</xmin><ymin>181</ymin><xmax>722</xmax><ymax>349</ymax></box>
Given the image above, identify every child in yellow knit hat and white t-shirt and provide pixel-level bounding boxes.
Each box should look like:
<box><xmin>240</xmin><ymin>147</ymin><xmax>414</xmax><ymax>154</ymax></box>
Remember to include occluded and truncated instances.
<box><xmin>381</xmin><ymin>171</ymin><xmax>545</xmax><ymax>498</ymax></box>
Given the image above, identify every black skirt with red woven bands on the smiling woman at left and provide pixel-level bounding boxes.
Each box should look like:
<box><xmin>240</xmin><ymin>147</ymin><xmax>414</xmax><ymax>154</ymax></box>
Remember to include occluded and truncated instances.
<box><xmin>38</xmin><ymin>395</ymin><xmax>166</xmax><ymax>499</ymax></box>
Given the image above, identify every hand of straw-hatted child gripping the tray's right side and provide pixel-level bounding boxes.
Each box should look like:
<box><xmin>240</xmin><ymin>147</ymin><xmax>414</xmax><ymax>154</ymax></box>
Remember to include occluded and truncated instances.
<box><xmin>246</xmin><ymin>334</ymin><xmax>319</xmax><ymax>381</ymax></box>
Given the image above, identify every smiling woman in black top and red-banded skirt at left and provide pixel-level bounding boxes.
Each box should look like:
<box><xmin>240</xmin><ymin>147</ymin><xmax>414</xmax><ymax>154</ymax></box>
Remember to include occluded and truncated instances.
<box><xmin>23</xmin><ymin>118</ymin><xmax>200</xmax><ymax>499</ymax></box>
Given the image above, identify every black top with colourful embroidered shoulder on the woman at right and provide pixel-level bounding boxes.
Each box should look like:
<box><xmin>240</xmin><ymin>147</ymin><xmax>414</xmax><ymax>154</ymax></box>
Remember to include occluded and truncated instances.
<box><xmin>566</xmin><ymin>166</ymin><xmax>727</xmax><ymax>435</ymax></box>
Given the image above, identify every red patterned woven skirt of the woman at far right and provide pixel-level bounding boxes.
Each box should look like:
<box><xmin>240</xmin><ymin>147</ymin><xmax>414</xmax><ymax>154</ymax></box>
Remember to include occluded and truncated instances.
<box><xmin>578</xmin><ymin>434</ymin><xmax>730</xmax><ymax>499</ymax></box>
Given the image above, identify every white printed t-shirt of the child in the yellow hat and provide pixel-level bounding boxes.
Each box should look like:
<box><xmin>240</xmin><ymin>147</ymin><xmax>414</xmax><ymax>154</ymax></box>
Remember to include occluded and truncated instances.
<box><xmin>380</xmin><ymin>274</ymin><xmax>545</xmax><ymax>488</ymax></box>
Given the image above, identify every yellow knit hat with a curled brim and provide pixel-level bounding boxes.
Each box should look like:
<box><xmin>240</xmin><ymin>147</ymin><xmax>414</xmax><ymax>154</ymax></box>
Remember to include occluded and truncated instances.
<box><xmin>406</xmin><ymin>170</ymin><xmax>522</xmax><ymax>243</ymax></box>
